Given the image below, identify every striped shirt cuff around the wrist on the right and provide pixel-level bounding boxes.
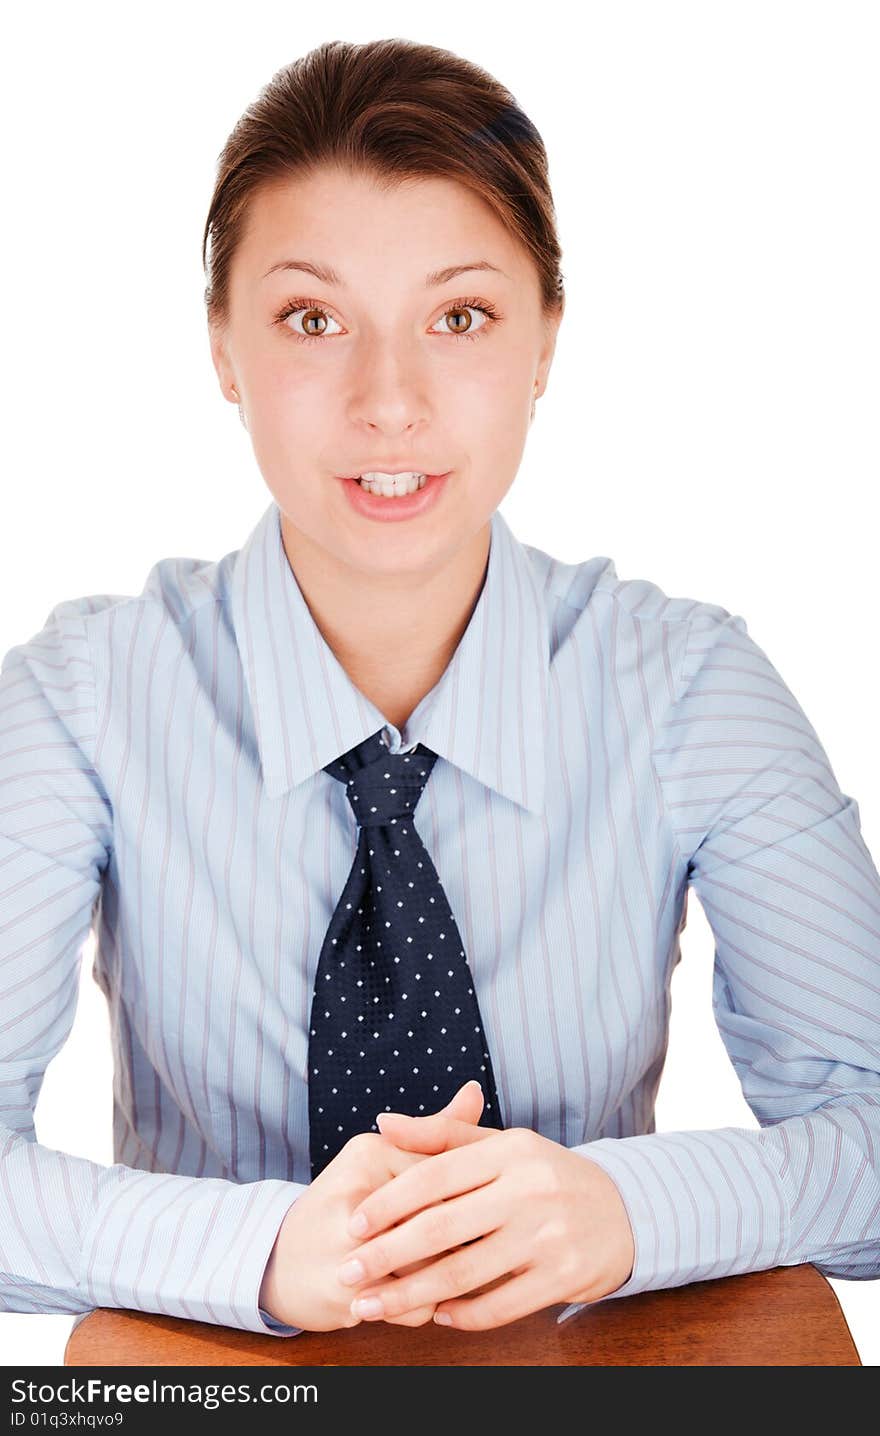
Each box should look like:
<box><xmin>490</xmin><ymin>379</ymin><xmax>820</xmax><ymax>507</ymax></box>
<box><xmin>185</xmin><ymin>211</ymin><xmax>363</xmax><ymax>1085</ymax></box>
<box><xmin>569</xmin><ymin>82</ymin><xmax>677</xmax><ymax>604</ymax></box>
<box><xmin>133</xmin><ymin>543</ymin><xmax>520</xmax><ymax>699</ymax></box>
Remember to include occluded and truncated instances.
<box><xmin>557</xmin><ymin>1127</ymin><xmax>791</xmax><ymax>1323</ymax></box>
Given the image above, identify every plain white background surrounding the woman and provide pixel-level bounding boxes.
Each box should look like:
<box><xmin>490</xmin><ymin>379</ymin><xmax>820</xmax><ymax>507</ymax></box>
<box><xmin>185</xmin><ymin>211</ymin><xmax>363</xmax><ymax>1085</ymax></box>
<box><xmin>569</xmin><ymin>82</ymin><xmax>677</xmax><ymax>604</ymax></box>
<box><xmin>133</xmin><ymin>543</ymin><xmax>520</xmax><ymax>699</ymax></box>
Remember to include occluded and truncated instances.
<box><xmin>0</xmin><ymin>0</ymin><xmax>880</xmax><ymax>1366</ymax></box>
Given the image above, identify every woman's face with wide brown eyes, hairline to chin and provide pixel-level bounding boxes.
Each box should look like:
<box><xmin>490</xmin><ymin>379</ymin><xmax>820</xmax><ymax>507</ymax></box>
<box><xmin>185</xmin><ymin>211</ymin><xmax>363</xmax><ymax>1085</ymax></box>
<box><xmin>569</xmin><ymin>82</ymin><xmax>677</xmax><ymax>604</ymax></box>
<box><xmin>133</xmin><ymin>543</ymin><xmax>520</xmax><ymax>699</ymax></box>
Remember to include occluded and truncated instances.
<box><xmin>211</xmin><ymin>167</ymin><xmax>558</xmax><ymax>574</ymax></box>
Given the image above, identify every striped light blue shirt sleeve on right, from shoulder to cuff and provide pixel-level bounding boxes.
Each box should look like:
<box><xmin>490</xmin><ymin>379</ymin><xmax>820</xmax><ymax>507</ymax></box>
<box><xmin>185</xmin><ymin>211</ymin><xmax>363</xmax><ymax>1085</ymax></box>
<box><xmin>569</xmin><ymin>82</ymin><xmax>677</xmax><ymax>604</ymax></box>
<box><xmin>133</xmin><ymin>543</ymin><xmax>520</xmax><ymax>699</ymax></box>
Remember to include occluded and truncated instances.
<box><xmin>557</xmin><ymin>605</ymin><xmax>880</xmax><ymax>1321</ymax></box>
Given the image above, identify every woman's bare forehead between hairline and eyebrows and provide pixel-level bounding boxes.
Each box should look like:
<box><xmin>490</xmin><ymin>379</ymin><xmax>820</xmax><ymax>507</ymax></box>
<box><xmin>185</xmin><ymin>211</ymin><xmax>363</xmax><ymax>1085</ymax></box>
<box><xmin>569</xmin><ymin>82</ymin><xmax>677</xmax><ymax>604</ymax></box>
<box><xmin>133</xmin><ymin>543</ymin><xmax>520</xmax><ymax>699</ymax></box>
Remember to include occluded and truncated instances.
<box><xmin>229</xmin><ymin>167</ymin><xmax>525</xmax><ymax>284</ymax></box>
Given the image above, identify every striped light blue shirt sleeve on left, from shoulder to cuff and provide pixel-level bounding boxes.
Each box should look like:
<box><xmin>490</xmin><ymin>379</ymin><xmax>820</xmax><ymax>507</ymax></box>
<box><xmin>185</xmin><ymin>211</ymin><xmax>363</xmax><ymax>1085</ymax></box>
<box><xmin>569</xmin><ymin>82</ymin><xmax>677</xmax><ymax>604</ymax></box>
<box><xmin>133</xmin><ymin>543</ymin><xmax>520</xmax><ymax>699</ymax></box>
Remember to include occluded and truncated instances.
<box><xmin>0</xmin><ymin>600</ymin><xmax>304</xmax><ymax>1335</ymax></box>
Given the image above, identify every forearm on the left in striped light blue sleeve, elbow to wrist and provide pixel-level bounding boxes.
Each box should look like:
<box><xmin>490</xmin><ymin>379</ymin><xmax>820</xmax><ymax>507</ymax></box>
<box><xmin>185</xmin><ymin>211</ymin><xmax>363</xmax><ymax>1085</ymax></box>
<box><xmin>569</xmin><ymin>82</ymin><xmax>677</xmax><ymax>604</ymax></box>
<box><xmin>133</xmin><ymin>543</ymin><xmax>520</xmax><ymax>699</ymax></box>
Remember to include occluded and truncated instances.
<box><xmin>0</xmin><ymin>1127</ymin><xmax>303</xmax><ymax>1335</ymax></box>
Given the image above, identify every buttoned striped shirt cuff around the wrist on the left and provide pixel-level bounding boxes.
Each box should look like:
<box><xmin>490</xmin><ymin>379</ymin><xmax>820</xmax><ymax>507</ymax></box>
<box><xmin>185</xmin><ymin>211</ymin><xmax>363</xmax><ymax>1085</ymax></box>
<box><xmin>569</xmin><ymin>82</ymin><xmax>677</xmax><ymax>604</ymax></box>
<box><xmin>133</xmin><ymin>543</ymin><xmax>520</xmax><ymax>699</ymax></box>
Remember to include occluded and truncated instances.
<box><xmin>79</xmin><ymin>1165</ymin><xmax>306</xmax><ymax>1335</ymax></box>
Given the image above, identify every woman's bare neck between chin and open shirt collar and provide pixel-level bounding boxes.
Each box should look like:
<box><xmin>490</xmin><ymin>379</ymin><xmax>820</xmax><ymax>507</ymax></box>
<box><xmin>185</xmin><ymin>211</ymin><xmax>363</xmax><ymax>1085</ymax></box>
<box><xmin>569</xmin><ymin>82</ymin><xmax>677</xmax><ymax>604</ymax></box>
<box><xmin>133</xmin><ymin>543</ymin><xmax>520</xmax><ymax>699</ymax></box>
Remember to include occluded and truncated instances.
<box><xmin>281</xmin><ymin>513</ymin><xmax>491</xmax><ymax>732</ymax></box>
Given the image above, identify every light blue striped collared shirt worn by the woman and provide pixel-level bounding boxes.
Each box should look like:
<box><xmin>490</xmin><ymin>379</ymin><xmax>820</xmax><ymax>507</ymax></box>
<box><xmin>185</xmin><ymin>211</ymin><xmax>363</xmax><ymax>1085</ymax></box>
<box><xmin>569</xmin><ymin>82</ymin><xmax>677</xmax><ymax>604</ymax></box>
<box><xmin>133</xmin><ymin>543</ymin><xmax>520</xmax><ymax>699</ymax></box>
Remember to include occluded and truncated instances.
<box><xmin>0</xmin><ymin>503</ymin><xmax>880</xmax><ymax>1335</ymax></box>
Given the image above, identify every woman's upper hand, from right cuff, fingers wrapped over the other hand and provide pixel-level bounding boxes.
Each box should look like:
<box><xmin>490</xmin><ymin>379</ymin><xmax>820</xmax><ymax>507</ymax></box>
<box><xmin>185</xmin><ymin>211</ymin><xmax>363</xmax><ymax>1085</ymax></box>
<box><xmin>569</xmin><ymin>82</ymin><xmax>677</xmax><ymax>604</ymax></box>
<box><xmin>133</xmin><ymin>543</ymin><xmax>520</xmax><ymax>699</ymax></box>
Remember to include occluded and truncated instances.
<box><xmin>337</xmin><ymin>1087</ymin><xmax>635</xmax><ymax>1331</ymax></box>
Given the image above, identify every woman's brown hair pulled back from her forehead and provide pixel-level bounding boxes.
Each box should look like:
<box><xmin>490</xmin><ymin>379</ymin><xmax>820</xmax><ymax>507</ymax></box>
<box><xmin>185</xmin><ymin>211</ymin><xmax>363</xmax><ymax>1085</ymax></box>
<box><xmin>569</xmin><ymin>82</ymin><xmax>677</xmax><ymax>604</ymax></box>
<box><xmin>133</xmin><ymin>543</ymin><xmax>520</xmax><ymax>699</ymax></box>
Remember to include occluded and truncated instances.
<box><xmin>202</xmin><ymin>39</ymin><xmax>564</xmax><ymax>327</ymax></box>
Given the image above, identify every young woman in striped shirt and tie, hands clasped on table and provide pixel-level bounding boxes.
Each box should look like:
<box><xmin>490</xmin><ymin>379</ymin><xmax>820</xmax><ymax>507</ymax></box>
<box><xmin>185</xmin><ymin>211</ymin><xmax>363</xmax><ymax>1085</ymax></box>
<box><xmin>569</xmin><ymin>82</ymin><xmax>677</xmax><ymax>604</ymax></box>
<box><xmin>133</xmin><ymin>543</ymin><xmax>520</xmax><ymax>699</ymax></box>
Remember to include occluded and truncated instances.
<box><xmin>0</xmin><ymin>40</ymin><xmax>880</xmax><ymax>1335</ymax></box>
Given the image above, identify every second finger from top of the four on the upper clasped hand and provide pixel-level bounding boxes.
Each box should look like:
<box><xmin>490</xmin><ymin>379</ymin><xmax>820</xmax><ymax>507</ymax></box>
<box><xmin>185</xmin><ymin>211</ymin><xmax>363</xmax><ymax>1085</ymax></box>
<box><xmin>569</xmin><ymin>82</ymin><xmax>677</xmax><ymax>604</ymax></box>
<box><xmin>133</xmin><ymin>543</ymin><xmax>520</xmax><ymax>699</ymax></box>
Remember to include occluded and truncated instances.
<box><xmin>336</xmin><ymin>1182</ymin><xmax>510</xmax><ymax>1290</ymax></box>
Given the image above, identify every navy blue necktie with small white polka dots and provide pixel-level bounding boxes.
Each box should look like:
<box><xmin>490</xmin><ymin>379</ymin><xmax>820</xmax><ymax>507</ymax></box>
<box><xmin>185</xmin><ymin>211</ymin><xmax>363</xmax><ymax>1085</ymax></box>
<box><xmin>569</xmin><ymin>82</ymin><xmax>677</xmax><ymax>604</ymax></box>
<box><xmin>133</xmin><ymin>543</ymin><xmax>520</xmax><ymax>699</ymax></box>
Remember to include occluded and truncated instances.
<box><xmin>309</xmin><ymin>729</ymin><xmax>502</xmax><ymax>1179</ymax></box>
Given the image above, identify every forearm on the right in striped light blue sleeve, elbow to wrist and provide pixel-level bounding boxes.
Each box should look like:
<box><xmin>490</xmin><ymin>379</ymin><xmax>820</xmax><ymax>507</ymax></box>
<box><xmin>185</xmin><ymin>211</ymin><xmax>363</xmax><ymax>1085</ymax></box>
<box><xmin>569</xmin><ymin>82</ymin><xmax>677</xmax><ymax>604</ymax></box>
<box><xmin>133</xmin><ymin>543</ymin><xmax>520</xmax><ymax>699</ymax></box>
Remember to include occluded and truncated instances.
<box><xmin>556</xmin><ymin>1091</ymin><xmax>880</xmax><ymax>1315</ymax></box>
